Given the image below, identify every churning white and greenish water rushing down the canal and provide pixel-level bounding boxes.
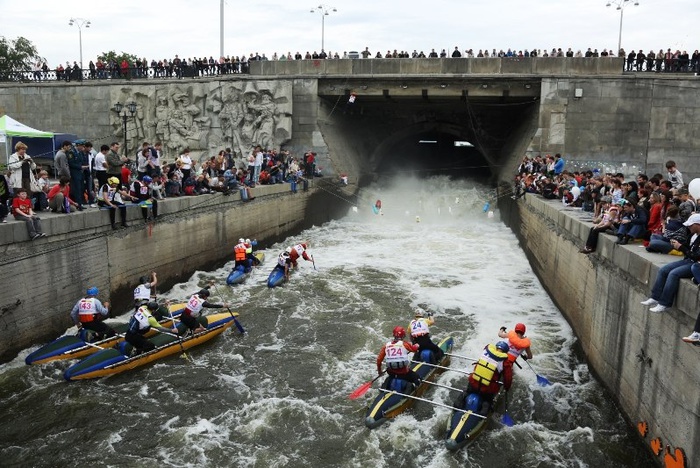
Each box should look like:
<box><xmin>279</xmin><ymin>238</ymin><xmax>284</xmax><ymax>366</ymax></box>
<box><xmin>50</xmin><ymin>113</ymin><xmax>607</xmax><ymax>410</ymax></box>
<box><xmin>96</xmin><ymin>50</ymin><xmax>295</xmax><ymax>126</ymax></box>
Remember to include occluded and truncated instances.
<box><xmin>0</xmin><ymin>179</ymin><xmax>652</xmax><ymax>468</ymax></box>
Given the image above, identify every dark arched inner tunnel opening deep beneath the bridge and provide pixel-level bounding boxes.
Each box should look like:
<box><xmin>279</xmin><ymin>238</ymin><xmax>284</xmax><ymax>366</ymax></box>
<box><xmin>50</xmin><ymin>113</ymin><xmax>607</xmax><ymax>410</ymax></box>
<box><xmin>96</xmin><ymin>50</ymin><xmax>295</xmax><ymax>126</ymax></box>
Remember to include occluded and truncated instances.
<box><xmin>376</xmin><ymin>131</ymin><xmax>493</xmax><ymax>182</ymax></box>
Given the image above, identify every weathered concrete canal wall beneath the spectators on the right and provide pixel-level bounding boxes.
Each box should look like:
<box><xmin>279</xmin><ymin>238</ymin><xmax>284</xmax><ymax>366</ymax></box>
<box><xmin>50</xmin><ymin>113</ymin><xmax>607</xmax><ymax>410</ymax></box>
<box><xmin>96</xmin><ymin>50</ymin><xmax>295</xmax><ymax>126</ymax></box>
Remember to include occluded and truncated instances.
<box><xmin>500</xmin><ymin>195</ymin><xmax>700</xmax><ymax>466</ymax></box>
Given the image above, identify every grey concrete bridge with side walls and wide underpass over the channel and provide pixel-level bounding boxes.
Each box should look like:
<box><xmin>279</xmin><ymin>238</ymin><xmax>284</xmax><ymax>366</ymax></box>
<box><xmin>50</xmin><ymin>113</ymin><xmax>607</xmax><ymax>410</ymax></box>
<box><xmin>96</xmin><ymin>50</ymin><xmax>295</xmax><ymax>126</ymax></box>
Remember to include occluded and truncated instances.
<box><xmin>0</xmin><ymin>57</ymin><xmax>700</xmax><ymax>188</ymax></box>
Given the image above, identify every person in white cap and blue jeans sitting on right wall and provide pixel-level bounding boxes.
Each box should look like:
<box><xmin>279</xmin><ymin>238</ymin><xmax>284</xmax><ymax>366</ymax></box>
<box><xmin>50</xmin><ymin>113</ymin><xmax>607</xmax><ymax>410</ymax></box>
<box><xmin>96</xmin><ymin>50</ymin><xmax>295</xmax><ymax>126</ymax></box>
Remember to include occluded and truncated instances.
<box><xmin>642</xmin><ymin>213</ymin><xmax>700</xmax><ymax>313</ymax></box>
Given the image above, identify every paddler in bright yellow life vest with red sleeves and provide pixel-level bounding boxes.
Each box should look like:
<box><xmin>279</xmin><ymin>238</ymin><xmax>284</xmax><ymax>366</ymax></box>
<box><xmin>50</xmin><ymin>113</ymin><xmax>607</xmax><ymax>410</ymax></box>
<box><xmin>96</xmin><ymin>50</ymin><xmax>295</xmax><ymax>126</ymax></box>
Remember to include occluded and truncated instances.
<box><xmin>455</xmin><ymin>341</ymin><xmax>513</xmax><ymax>415</ymax></box>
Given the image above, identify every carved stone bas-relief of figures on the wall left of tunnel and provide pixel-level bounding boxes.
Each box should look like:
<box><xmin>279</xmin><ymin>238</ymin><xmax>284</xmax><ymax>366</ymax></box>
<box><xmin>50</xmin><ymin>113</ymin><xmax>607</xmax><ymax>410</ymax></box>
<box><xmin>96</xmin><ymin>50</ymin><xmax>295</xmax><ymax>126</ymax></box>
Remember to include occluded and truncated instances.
<box><xmin>111</xmin><ymin>80</ymin><xmax>292</xmax><ymax>160</ymax></box>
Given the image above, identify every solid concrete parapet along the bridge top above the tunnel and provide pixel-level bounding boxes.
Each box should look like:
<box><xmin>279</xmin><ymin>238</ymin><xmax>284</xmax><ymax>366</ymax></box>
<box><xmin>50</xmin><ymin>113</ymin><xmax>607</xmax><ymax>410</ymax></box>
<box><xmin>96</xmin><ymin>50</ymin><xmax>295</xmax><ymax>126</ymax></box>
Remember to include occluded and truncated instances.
<box><xmin>250</xmin><ymin>57</ymin><xmax>624</xmax><ymax>76</ymax></box>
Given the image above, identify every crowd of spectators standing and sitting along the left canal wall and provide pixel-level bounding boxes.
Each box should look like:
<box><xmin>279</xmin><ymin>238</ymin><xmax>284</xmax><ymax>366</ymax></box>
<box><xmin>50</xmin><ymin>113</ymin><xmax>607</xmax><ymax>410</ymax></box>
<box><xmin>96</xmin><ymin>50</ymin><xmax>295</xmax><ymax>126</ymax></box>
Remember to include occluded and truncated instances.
<box><xmin>0</xmin><ymin>139</ymin><xmax>322</xmax><ymax>234</ymax></box>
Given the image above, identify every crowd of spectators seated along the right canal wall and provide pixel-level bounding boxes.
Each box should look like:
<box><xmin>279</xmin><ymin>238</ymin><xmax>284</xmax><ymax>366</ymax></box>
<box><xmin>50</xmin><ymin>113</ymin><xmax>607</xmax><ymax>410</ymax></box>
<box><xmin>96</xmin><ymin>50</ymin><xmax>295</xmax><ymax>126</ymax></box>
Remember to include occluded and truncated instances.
<box><xmin>512</xmin><ymin>154</ymin><xmax>700</xmax><ymax>344</ymax></box>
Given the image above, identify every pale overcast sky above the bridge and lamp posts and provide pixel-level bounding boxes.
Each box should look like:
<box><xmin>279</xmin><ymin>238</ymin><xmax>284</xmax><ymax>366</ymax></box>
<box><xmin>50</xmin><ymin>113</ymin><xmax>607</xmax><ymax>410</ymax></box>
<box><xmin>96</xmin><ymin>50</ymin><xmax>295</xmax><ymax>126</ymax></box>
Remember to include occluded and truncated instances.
<box><xmin>0</xmin><ymin>0</ymin><xmax>700</xmax><ymax>68</ymax></box>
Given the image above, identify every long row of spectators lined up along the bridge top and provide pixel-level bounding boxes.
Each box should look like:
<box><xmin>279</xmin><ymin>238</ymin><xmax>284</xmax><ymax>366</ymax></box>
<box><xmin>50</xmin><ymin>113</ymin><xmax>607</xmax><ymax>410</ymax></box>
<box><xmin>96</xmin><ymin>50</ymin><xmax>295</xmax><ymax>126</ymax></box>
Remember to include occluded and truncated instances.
<box><xmin>6</xmin><ymin>47</ymin><xmax>700</xmax><ymax>81</ymax></box>
